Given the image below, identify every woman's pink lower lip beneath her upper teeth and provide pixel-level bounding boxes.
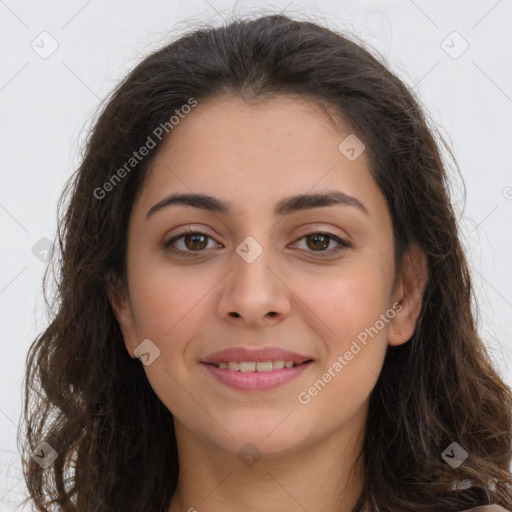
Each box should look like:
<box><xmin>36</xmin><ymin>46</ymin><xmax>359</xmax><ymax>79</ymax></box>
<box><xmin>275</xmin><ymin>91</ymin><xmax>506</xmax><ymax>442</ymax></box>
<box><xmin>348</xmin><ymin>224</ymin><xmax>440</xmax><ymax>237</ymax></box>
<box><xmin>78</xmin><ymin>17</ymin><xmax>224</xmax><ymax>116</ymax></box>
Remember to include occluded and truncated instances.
<box><xmin>202</xmin><ymin>361</ymin><xmax>313</xmax><ymax>391</ymax></box>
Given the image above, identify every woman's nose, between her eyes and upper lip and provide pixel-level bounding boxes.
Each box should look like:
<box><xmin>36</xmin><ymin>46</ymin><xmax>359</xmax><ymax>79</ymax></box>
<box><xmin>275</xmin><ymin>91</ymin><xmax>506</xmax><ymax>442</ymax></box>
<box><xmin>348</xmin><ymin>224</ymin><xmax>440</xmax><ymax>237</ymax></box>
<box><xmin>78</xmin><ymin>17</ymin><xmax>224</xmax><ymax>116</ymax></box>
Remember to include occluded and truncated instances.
<box><xmin>219</xmin><ymin>238</ymin><xmax>291</xmax><ymax>326</ymax></box>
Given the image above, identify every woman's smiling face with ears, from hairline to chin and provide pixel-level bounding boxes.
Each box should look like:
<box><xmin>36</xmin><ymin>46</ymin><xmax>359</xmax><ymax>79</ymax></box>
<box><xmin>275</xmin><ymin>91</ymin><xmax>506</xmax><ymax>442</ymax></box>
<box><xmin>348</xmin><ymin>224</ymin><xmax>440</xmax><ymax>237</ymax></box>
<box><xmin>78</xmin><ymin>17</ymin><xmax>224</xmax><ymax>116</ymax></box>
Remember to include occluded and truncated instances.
<box><xmin>111</xmin><ymin>97</ymin><xmax>426</xmax><ymax>460</ymax></box>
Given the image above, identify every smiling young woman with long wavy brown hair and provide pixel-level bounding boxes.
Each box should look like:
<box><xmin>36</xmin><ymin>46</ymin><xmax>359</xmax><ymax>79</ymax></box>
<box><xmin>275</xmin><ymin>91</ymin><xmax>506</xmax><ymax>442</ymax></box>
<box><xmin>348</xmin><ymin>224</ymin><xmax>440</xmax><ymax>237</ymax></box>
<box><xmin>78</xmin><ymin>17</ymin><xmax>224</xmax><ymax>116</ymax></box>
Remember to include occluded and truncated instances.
<box><xmin>21</xmin><ymin>15</ymin><xmax>512</xmax><ymax>512</ymax></box>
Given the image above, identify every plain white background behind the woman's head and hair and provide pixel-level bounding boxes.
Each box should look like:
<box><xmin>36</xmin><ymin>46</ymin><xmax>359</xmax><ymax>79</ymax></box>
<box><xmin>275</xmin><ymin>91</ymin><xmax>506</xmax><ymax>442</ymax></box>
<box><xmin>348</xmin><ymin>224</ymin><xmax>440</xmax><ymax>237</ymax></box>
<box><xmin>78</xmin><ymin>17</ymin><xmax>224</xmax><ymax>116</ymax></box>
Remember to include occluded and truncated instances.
<box><xmin>0</xmin><ymin>0</ymin><xmax>512</xmax><ymax>511</ymax></box>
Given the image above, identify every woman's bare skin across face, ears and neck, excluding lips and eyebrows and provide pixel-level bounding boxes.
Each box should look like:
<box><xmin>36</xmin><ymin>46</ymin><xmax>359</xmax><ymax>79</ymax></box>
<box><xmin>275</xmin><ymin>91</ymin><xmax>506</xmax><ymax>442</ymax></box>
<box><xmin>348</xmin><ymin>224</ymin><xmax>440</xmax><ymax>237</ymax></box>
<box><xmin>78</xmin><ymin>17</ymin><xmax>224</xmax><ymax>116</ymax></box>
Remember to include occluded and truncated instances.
<box><xmin>110</xmin><ymin>96</ymin><xmax>427</xmax><ymax>512</ymax></box>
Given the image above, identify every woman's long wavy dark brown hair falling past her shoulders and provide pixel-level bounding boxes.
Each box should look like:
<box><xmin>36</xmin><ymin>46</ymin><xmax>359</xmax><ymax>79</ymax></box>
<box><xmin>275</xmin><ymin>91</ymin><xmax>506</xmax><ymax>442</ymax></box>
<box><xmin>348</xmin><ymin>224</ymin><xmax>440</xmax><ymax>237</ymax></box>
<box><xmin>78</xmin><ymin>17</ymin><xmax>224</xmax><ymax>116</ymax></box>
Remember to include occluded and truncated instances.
<box><xmin>23</xmin><ymin>15</ymin><xmax>512</xmax><ymax>512</ymax></box>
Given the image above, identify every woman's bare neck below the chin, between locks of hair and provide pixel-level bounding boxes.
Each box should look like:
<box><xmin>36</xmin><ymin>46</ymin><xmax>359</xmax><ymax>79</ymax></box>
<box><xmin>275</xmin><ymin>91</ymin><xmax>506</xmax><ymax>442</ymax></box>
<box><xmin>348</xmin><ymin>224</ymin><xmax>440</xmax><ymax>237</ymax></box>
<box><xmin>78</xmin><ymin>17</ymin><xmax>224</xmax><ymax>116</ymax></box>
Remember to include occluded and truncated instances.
<box><xmin>169</xmin><ymin>411</ymin><xmax>365</xmax><ymax>512</ymax></box>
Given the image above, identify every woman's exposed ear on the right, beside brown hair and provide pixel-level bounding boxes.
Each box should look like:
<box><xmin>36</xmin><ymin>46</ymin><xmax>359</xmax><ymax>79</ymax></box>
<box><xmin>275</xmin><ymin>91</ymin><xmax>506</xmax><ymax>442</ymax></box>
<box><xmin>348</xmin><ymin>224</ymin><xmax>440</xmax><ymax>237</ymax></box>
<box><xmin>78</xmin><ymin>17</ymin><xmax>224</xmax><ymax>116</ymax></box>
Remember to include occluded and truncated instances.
<box><xmin>388</xmin><ymin>244</ymin><xmax>428</xmax><ymax>346</ymax></box>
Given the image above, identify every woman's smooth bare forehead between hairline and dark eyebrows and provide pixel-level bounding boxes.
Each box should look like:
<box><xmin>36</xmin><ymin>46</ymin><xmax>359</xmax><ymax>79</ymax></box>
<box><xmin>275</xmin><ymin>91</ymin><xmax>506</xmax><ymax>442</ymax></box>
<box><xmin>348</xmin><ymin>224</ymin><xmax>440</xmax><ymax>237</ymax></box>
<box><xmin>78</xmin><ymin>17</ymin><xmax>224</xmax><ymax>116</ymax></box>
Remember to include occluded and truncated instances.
<box><xmin>134</xmin><ymin>96</ymin><xmax>385</xmax><ymax>222</ymax></box>
